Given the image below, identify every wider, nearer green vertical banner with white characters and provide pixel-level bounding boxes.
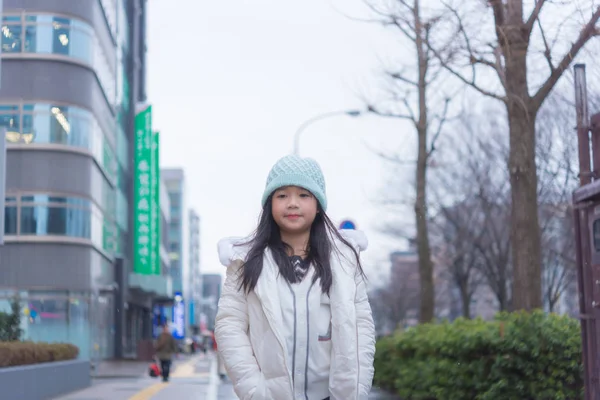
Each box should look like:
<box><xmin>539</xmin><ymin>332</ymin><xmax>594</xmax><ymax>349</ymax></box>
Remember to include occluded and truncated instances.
<box><xmin>133</xmin><ymin>105</ymin><xmax>155</xmax><ymax>275</ymax></box>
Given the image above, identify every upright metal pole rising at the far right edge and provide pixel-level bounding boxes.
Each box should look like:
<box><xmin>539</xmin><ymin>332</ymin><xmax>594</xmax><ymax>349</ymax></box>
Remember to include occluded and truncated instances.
<box><xmin>574</xmin><ymin>64</ymin><xmax>596</xmax><ymax>186</ymax></box>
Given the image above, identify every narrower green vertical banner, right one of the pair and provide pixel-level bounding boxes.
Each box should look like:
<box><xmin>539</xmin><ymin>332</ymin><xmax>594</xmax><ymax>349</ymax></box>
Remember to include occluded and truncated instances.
<box><xmin>150</xmin><ymin>132</ymin><xmax>161</xmax><ymax>275</ymax></box>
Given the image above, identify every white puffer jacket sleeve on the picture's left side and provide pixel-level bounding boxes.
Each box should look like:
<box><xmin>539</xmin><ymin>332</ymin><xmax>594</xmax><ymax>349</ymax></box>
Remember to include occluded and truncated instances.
<box><xmin>215</xmin><ymin>261</ymin><xmax>266</xmax><ymax>400</ymax></box>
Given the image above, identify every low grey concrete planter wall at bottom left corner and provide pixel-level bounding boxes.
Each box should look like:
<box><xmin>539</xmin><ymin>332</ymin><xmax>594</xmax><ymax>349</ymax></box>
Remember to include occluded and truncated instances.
<box><xmin>0</xmin><ymin>360</ymin><xmax>91</xmax><ymax>400</ymax></box>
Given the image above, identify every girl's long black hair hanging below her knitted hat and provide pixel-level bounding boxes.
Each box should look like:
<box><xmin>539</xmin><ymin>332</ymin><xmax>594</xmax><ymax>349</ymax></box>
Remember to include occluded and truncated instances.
<box><xmin>240</xmin><ymin>194</ymin><xmax>364</xmax><ymax>294</ymax></box>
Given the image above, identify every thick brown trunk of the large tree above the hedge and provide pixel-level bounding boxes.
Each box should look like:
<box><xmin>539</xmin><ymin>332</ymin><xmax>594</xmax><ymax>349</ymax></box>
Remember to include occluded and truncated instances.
<box><xmin>497</xmin><ymin>0</ymin><xmax>542</xmax><ymax>310</ymax></box>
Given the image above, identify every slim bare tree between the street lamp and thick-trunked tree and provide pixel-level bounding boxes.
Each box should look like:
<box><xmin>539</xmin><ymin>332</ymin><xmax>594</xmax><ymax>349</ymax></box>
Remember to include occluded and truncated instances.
<box><xmin>366</xmin><ymin>0</ymin><xmax>449</xmax><ymax>322</ymax></box>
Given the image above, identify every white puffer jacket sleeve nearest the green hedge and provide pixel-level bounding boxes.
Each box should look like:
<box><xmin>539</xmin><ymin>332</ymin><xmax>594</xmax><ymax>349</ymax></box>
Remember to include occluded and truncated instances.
<box><xmin>354</xmin><ymin>264</ymin><xmax>375</xmax><ymax>400</ymax></box>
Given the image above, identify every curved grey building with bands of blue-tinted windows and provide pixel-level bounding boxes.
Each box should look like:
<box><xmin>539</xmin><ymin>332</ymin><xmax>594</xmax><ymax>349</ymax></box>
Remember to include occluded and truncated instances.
<box><xmin>0</xmin><ymin>0</ymin><xmax>166</xmax><ymax>359</ymax></box>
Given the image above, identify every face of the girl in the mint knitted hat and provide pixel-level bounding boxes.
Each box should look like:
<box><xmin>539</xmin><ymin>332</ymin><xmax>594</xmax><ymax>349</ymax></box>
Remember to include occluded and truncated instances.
<box><xmin>271</xmin><ymin>186</ymin><xmax>317</xmax><ymax>233</ymax></box>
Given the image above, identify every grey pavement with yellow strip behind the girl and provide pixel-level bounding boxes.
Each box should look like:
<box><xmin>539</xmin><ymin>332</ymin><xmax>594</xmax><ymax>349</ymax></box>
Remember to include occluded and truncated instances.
<box><xmin>54</xmin><ymin>356</ymin><xmax>394</xmax><ymax>400</ymax></box>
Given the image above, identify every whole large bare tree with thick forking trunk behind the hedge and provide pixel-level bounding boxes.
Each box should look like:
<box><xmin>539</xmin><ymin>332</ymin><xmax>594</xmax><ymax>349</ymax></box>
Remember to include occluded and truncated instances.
<box><xmin>427</xmin><ymin>0</ymin><xmax>600</xmax><ymax>310</ymax></box>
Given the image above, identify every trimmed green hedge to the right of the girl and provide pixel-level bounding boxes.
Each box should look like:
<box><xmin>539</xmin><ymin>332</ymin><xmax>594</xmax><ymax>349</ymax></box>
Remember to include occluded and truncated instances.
<box><xmin>374</xmin><ymin>311</ymin><xmax>583</xmax><ymax>400</ymax></box>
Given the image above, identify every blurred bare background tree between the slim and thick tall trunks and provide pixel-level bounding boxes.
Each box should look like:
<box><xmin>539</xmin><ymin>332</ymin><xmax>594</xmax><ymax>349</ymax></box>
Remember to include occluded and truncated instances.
<box><xmin>434</xmin><ymin>116</ymin><xmax>512</xmax><ymax>316</ymax></box>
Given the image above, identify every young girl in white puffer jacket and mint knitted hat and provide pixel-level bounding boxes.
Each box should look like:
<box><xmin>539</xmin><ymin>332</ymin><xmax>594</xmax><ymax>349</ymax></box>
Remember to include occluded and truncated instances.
<box><xmin>215</xmin><ymin>156</ymin><xmax>375</xmax><ymax>400</ymax></box>
